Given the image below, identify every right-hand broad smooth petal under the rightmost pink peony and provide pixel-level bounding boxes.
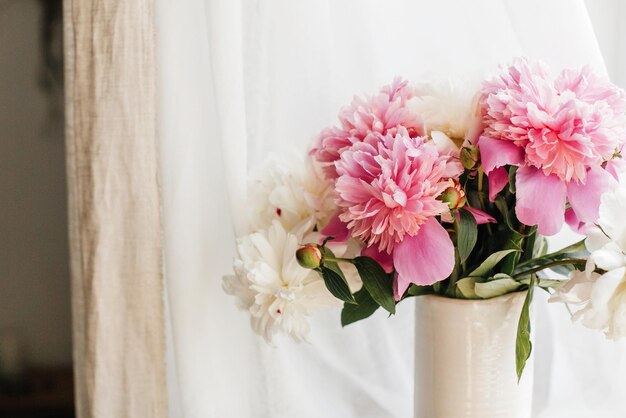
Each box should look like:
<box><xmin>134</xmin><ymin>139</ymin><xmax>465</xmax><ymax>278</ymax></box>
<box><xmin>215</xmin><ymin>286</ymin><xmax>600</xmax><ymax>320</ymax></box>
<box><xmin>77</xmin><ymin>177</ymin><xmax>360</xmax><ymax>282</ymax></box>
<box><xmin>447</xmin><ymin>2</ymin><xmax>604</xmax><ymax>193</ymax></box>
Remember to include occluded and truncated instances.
<box><xmin>567</xmin><ymin>167</ymin><xmax>617</xmax><ymax>223</ymax></box>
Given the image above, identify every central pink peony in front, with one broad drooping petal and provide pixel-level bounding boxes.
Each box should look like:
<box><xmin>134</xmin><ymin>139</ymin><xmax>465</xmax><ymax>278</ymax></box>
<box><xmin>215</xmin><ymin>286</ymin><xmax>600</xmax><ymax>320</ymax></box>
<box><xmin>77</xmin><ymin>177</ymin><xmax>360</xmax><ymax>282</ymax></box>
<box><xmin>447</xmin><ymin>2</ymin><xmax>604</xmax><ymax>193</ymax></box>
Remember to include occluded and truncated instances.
<box><xmin>335</xmin><ymin>128</ymin><xmax>463</xmax><ymax>298</ymax></box>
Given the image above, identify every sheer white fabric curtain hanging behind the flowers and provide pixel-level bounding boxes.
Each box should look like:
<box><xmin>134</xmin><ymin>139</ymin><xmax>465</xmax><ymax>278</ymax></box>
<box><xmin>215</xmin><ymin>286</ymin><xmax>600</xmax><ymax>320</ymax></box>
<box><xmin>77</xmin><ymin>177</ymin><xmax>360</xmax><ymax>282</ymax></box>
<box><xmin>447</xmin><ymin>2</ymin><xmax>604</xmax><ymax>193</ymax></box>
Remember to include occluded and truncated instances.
<box><xmin>158</xmin><ymin>0</ymin><xmax>626</xmax><ymax>418</ymax></box>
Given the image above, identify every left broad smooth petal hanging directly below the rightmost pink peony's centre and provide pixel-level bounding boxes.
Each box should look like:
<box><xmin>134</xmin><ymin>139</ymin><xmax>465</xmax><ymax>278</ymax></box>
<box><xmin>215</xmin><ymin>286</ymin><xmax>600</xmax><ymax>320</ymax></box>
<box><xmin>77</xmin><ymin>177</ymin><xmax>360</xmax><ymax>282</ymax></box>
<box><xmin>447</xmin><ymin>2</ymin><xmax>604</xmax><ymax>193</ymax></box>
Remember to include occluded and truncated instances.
<box><xmin>515</xmin><ymin>167</ymin><xmax>566</xmax><ymax>235</ymax></box>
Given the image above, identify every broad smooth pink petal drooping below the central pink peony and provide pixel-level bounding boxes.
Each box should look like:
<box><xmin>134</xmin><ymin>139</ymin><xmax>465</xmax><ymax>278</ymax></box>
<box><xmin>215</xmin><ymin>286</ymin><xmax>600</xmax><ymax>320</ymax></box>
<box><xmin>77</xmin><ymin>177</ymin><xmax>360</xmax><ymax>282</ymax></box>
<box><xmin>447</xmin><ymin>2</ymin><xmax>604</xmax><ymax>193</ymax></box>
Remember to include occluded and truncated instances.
<box><xmin>393</xmin><ymin>218</ymin><xmax>454</xmax><ymax>300</ymax></box>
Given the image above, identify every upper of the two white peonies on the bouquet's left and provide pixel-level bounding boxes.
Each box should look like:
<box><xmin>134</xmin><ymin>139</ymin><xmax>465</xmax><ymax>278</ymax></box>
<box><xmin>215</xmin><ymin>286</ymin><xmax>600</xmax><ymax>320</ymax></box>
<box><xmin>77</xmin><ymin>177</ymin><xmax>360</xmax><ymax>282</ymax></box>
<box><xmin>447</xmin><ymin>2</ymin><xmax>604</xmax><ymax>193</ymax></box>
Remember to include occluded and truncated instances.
<box><xmin>247</xmin><ymin>152</ymin><xmax>337</xmax><ymax>231</ymax></box>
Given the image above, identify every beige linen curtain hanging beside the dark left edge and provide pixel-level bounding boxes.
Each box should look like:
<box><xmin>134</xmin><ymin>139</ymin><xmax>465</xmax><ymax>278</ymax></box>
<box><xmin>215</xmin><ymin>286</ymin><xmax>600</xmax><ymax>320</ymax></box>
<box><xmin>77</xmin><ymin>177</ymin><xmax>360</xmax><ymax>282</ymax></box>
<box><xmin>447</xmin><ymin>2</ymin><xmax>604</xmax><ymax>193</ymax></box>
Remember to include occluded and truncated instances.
<box><xmin>64</xmin><ymin>0</ymin><xmax>167</xmax><ymax>418</ymax></box>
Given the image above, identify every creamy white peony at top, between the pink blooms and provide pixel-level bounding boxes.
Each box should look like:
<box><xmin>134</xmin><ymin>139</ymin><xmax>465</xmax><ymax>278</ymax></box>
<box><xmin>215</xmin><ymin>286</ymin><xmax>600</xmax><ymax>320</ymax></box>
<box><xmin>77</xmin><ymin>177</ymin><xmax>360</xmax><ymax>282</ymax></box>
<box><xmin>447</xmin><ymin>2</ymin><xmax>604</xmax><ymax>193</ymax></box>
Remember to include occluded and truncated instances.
<box><xmin>407</xmin><ymin>77</ymin><xmax>480</xmax><ymax>147</ymax></box>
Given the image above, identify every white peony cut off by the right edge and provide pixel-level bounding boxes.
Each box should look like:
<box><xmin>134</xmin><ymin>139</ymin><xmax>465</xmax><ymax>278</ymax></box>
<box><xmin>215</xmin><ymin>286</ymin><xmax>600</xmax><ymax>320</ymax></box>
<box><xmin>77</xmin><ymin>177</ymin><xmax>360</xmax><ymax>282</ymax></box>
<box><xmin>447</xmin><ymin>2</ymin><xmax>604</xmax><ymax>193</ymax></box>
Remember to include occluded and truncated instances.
<box><xmin>550</xmin><ymin>188</ymin><xmax>626</xmax><ymax>339</ymax></box>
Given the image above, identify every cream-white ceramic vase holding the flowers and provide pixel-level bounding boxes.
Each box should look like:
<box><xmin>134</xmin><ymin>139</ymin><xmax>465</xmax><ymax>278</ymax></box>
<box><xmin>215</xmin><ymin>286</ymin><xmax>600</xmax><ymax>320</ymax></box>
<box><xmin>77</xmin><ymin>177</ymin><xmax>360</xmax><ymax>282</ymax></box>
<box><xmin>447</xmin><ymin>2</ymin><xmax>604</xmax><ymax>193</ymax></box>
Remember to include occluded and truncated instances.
<box><xmin>415</xmin><ymin>292</ymin><xmax>533</xmax><ymax>418</ymax></box>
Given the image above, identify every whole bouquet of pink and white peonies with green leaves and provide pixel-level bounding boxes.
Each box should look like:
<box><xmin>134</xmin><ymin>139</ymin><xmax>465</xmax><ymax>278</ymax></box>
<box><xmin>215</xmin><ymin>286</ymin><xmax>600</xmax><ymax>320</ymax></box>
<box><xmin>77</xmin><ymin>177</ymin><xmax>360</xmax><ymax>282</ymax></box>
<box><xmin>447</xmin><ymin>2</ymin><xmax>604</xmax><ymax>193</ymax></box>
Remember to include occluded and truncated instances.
<box><xmin>224</xmin><ymin>58</ymin><xmax>626</xmax><ymax>376</ymax></box>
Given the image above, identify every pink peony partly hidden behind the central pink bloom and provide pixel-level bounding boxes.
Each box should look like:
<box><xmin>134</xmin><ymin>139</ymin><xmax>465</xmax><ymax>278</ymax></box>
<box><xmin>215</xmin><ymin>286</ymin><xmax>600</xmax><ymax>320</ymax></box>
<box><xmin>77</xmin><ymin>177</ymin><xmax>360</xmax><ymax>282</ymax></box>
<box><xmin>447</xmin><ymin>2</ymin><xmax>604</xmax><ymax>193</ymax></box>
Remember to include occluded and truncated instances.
<box><xmin>310</xmin><ymin>78</ymin><xmax>422</xmax><ymax>179</ymax></box>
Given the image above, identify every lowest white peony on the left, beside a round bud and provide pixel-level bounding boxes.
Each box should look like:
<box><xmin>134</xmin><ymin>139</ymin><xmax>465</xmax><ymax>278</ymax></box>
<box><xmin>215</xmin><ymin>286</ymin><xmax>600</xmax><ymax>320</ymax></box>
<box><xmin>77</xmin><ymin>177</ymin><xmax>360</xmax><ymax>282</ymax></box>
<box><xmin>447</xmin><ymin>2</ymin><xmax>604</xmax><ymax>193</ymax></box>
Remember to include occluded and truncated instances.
<box><xmin>223</xmin><ymin>219</ymin><xmax>341</xmax><ymax>342</ymax></box>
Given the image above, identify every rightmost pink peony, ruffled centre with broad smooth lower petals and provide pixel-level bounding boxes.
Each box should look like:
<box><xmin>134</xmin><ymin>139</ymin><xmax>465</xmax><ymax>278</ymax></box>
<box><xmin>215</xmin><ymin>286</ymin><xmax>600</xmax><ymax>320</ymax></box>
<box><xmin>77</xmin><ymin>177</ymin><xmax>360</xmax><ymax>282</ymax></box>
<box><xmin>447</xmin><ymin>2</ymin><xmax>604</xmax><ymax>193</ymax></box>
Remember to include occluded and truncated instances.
<box><xmin>478</xmin><ymin>59</ymin><xmax>626</xmax><ymax>235</ymax></box>
